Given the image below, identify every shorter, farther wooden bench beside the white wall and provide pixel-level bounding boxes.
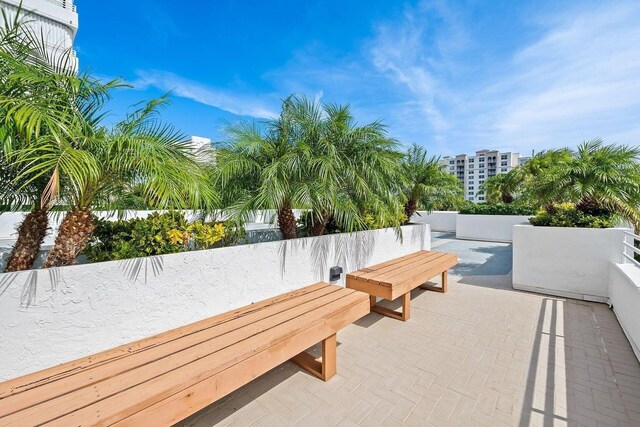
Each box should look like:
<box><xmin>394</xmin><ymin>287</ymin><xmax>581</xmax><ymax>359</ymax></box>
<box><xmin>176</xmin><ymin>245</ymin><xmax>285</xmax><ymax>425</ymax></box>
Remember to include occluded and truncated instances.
<box><xmin>347</xmin><ymin>251</ymin><xmax>458</xmax><ymax>321</ymax></box>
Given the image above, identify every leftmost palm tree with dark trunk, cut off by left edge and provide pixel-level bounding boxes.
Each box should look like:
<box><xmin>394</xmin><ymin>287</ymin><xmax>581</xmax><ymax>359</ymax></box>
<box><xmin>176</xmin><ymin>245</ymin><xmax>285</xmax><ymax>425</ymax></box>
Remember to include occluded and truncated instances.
<box><xmin>0</xmin><ymin>10</ymin><xmax>117</xmax><ymax>271</ymax></box>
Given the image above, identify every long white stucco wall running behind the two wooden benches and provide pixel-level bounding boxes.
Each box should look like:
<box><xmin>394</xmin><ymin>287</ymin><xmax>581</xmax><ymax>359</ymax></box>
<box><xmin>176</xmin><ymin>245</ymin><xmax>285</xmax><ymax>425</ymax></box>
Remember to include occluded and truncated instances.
<box><xmin>0</xmin><ymin>224</ymin><xmax>431</xmax><ymax>381</ymax></box>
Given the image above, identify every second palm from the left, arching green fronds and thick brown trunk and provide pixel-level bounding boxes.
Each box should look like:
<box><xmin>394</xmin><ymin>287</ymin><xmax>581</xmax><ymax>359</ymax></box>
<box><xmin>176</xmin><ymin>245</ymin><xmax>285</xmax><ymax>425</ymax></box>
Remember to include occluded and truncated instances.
<box><xmin>17</xmin><ymin>98</ymin><xmax>216</xmax><ymax>268</ymax></box>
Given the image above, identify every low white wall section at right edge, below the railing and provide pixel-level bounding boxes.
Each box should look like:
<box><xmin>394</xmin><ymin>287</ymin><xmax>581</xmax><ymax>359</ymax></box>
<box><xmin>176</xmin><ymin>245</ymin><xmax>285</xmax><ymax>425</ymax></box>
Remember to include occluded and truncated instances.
<box><xmin>609</xmin><ymin>263</ymin><xmax>640</xmax><ymax>360</ymax></box>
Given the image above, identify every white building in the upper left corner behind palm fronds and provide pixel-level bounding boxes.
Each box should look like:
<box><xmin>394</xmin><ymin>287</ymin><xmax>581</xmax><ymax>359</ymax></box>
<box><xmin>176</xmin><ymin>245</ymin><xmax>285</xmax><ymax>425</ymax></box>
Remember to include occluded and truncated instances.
<box><xmin>0</xmin><ymin>0</ymin><xmax>78</xmax><ymax>70</ymax></box>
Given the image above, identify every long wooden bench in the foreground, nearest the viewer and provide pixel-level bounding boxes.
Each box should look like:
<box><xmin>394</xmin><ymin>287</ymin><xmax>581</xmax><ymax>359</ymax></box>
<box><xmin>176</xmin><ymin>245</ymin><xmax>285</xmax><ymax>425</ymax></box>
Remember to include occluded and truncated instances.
<box><xmin>0</xmin><ymin>283</ymin><xmax>369</xmax><ymax>426</ymax></box>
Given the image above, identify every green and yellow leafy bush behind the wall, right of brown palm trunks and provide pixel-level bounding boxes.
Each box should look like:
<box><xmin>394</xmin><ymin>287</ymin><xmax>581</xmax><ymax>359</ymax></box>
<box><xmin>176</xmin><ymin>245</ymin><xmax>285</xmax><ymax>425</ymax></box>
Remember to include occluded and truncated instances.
<box><xmin>84</xmin><ymin>212</ymin><xmax>238</xmax><ymax>262</ymax></box>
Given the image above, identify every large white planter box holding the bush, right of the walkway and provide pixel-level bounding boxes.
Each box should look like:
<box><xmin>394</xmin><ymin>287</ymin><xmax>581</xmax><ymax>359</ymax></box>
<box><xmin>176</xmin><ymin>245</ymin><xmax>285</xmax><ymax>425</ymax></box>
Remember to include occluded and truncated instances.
<box><xmin>513</xmin><ymin>225</ymin><xmax>627</xmax><ymax>302</ymax></box>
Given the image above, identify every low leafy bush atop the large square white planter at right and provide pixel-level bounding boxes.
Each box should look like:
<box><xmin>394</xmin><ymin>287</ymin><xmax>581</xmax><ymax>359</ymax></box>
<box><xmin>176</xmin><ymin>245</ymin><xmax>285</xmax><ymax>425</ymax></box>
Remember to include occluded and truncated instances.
<box><xmin>529</xmin><ymin>203</ymin><xmax>615</xmax><ymax>228</ymax></box>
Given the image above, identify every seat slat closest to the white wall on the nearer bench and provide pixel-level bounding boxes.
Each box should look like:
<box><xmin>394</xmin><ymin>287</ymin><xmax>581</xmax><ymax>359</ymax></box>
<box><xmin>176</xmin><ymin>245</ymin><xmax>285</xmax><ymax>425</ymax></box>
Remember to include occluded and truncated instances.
<box><xmin>0</xmin><ymin>282</ymin><xmax>327</xmax><ymax>400</ymax></box>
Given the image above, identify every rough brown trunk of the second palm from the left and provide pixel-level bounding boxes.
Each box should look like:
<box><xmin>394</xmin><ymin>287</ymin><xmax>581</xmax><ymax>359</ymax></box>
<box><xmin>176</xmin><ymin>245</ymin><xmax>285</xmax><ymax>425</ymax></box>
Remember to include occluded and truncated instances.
<box><xmin>43</xmin><ymin>208</ymin><xmax>95</xmax><ymax>268</ymax></box>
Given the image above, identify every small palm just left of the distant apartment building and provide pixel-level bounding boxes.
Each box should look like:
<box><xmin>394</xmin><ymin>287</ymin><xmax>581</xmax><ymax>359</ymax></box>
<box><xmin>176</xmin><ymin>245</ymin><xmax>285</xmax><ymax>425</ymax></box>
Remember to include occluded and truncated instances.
<box><xmin>403</xmin><ymin>144</ymin><xmax>463</xmax><ymax>221</ymax></box>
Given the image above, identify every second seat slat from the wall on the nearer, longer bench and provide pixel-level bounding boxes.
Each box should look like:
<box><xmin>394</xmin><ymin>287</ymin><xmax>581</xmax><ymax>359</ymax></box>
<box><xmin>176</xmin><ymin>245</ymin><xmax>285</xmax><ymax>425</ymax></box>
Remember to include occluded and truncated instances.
<box><xmin>0</xmin><ymin>285</ymin><xmax>339</xmax><ymax>414</ymax></box>
